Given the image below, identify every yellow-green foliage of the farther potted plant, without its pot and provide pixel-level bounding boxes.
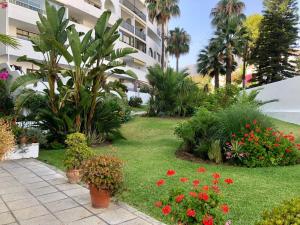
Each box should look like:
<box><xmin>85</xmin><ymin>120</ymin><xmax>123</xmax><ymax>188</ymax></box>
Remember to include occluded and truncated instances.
<box><xmin>64</xmin><ymin>133</ymin><xmax>94</xmax><ymax>170</ymax></box>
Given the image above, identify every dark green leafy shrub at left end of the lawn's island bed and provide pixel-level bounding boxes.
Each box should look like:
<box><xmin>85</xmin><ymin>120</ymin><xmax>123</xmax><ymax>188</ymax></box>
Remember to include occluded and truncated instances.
<box><xmin>175</xmin><ymin>108</ymin><xmax>218</xmax><ymax>159</ymax></box>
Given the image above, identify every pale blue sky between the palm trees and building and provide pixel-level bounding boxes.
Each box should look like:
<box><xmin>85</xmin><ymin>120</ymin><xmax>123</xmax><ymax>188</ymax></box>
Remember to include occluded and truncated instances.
<box><xmin>169</xmin><ymin>0</ymin><xmax>264</xmax><ymax>68</ymax></box>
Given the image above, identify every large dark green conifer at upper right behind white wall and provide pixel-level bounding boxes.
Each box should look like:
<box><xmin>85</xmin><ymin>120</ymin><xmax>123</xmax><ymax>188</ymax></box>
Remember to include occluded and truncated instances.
<box><xmin>252</xmin><ymin>0</ymin><xmax>299</xmax><ymax>85</ymax></box>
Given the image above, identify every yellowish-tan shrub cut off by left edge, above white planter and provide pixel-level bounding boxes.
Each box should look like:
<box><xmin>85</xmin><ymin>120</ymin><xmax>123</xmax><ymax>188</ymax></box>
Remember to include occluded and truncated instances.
<box><xmin>0</xmin><ymin>120</ymin><xmax>15</xmax><ymax>160</ymax></box>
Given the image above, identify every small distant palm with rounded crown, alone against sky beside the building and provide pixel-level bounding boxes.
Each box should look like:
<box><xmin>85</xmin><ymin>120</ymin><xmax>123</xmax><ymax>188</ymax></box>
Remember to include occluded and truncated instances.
<box><xmin>167</xmin><ymin>27</ymin><xmax>191</xmax><ymax>72</ymax></box>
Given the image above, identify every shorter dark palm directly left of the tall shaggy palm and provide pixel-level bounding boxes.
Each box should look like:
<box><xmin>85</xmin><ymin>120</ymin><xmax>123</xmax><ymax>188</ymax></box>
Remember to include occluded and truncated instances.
<box><xmin>197</xmin><ymin>39</ymin><xmax>225</xmax><ymax>89</ymax></box>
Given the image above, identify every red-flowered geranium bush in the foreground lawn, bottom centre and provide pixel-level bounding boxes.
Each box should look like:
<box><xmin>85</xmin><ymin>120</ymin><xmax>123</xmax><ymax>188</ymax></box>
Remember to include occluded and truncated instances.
<box><xmin>155</xmin><ymin>167</ymin><xmax>234</xmax><ymax>225</ymax></box>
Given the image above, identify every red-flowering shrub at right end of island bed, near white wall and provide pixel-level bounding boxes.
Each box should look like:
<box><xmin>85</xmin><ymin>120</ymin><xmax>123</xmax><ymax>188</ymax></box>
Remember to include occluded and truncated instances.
<box><xmin>225</xmin><ymin>120</ymin><xmax>300</xmax><ymax>167</ymax></box>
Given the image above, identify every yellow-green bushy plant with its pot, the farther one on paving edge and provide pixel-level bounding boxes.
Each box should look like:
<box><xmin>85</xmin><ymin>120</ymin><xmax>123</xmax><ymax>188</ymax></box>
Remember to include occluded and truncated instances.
<box><xmin>64</xmin><ymin>133</ymin><xmax>94</xmax><ymax>184</ymax></box>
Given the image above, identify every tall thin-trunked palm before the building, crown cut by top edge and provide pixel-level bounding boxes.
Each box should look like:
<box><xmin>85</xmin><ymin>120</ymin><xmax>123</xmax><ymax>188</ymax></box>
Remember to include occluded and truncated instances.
<box><xmin>145</xmin><ymin>0</ymin><xmax>180</xmax><ymax>68</ymax></box>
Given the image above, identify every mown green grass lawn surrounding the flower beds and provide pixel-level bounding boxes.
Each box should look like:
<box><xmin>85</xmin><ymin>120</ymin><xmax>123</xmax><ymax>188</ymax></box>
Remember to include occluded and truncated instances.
<box><xmin>40</xmin><ymin>118</ymin><xmax>300</xmax><ymax>225</ymax></box>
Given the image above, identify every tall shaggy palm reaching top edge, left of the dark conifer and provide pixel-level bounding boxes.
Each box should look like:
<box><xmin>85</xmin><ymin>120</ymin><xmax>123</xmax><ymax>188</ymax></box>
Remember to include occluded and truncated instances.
<box><xmin>211</xmin><ymin>0</ymin><xmax>246</xmax><ymax>85</ymax></box>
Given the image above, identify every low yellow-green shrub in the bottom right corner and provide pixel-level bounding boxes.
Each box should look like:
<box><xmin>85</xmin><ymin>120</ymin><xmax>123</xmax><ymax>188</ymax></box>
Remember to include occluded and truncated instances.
<box><xmin>256</xmin><ymin>197</ymin><xmax>300</xmax><ymax>225</ymax></box>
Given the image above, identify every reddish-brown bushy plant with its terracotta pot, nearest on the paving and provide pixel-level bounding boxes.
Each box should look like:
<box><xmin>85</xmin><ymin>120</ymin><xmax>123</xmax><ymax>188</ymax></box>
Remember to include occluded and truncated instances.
<box><xmin>82</xmin><ymin>155</ymin><xmax>123</xmax><ymax>208</ymax></box>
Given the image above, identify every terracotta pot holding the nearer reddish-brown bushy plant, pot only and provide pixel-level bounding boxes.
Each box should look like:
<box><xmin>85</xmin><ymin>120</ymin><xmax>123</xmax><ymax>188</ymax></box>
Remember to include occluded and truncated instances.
<box><xmin>89</xmin><ymin>184</ymin><xmax>110</xmax><ymax>209</ymax></box>
